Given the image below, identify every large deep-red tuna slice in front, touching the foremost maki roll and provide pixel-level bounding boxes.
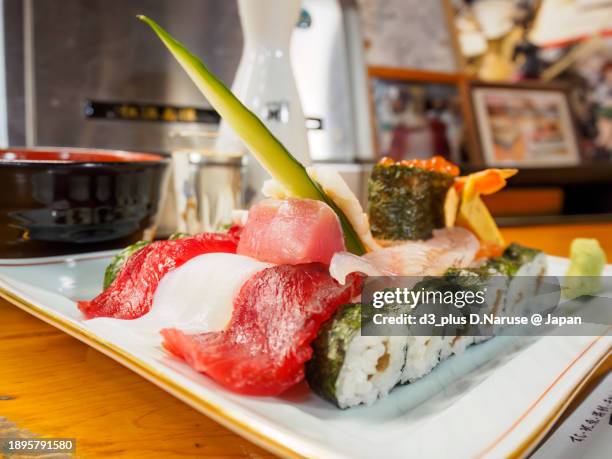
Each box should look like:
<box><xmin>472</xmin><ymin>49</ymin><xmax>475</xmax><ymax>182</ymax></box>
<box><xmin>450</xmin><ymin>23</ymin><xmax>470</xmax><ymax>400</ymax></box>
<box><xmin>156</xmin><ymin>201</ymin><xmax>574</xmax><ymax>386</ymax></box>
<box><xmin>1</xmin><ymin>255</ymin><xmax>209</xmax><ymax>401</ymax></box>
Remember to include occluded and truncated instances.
<box><xmin>161</xmin><ymin>263</ymin><xmax>361</xmax><ymax>395</ymax></box>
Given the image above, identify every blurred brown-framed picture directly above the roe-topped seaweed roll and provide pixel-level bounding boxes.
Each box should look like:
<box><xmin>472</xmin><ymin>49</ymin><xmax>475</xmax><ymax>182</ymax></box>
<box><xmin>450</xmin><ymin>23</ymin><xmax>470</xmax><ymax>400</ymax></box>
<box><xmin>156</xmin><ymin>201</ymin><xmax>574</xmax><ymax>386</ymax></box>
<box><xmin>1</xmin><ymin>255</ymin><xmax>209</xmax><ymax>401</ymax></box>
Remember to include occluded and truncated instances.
<box><xmin>369</xmin><ymin>67</ymin><xmax>474</xmax><ymax>162</ymax></box>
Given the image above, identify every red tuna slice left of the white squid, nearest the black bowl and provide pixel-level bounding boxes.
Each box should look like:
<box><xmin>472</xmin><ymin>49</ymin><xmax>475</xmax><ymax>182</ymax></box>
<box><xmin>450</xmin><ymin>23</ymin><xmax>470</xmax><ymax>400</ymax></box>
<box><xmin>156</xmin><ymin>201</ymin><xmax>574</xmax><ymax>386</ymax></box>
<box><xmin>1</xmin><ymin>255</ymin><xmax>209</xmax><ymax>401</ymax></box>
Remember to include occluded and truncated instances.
<box><xmin>78</xmin><ymin>233</ymin><xmax>237</xmax><ymax>319</ymax></box>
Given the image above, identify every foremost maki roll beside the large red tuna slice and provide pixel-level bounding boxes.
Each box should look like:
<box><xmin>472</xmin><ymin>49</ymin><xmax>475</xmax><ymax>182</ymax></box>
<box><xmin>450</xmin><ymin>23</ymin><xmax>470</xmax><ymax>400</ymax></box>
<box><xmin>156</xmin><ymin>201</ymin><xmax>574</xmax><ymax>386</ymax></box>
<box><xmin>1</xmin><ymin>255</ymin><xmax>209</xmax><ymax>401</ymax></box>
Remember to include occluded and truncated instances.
<box><xmin>306</xmin><ymin>304</ymin><xmax>407</xmax><ymax>409</ymax></box>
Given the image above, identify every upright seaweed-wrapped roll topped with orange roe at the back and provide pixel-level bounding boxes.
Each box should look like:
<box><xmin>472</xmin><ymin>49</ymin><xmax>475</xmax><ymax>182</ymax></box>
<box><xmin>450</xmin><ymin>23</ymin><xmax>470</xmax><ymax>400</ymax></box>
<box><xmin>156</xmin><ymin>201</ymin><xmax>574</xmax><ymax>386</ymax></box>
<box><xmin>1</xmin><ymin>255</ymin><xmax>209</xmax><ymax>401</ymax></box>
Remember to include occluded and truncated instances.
<box><xmin>368</xmin><ymin>157</ymin><xmax>459</xmax><ymax>241</ymax></box>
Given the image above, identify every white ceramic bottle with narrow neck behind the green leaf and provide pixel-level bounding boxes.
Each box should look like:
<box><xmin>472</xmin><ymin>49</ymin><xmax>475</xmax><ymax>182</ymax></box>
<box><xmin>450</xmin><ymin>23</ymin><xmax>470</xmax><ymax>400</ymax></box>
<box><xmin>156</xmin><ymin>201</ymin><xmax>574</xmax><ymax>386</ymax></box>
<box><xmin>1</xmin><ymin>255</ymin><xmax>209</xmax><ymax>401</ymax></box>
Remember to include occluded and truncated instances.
<box><xmin>219</xmin><ymin>0</ymin><xmax>310</xmax><ymax>201</ymax></box>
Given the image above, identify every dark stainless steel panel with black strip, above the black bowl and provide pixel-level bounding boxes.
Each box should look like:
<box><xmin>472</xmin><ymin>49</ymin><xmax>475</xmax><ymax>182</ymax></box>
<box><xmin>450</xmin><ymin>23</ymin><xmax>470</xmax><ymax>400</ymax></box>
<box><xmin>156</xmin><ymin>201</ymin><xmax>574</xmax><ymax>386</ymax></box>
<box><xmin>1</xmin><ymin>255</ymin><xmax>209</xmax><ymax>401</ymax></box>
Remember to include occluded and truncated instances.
<box><xmin>0</xmin><ymin>0</ymin><xmax>242</xmax><ymax>151</ymax></box>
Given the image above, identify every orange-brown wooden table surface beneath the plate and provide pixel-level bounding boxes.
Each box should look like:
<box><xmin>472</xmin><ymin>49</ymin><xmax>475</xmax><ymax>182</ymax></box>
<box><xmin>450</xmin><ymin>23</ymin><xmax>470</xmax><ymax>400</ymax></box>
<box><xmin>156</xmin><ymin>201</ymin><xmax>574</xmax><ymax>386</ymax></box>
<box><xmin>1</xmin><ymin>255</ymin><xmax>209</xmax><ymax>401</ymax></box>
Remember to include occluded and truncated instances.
<box><xmin>0</xmin><ymin>223</ymin><xmax>612</xmax><ymax>458</ymax></box>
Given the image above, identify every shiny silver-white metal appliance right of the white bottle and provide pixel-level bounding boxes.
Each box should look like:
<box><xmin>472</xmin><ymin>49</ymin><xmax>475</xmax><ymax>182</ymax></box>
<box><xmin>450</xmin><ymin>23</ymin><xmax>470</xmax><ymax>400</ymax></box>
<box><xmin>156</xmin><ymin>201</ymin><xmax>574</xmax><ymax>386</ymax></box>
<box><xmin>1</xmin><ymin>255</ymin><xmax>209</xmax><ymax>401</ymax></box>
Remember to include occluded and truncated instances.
<box><xmin>291</xmin><ymin>0</ymin><xmax>372</xmax><ymax>162</ymax></box>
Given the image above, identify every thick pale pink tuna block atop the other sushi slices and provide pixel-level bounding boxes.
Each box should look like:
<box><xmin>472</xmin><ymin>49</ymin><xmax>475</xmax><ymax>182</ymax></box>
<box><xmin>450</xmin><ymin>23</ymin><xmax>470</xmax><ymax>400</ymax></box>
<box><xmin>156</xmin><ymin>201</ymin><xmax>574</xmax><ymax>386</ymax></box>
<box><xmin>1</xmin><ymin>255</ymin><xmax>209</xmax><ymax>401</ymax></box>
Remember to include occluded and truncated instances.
<box><xmin>238</xmin><ymin>199</ymin><xmax>344</xmax><ymax>265</ymax></box>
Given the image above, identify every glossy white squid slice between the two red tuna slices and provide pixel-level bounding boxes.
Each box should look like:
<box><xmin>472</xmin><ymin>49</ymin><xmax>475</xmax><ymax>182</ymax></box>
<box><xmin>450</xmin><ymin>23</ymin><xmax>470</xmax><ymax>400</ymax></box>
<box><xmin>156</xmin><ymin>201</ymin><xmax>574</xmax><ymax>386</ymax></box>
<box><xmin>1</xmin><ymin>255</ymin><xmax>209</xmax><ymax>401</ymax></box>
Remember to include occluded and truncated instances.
<box><xmin>87</xmin><ymin>253</ymin><xmax>272</xmax><ymax>341</ymax></box>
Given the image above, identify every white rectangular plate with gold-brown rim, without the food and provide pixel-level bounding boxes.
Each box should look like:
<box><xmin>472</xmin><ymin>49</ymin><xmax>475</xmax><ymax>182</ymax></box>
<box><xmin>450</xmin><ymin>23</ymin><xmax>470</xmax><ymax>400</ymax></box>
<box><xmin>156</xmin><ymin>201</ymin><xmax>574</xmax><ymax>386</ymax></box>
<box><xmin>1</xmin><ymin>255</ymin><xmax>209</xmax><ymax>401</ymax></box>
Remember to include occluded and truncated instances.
<box><xmin>0</xmin><ymin>253</ymin><xmax>612</xmax><ymax>458</ymax></box>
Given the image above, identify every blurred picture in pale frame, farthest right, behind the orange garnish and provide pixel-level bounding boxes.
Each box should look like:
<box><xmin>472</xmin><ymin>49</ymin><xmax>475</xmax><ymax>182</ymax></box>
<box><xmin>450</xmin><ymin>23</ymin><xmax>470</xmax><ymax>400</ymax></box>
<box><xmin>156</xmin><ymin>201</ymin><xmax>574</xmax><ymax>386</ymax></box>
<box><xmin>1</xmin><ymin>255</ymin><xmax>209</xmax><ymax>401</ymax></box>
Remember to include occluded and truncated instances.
<box><xmin>471</xmin><ymin>84</ymin><xmax>580</xmax><ymax>167</ymax></box>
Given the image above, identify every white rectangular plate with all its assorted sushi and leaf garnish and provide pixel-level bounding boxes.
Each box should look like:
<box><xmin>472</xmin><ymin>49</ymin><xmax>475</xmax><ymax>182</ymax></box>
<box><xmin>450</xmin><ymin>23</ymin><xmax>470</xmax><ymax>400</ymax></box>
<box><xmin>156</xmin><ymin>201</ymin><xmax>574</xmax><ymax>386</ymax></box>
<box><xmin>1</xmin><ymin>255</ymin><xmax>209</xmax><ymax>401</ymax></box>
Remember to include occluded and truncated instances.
<box><xmin>0</xmin><ymin>17</ymin><xmax>612</xmax><ymax>458</ymax></box>
